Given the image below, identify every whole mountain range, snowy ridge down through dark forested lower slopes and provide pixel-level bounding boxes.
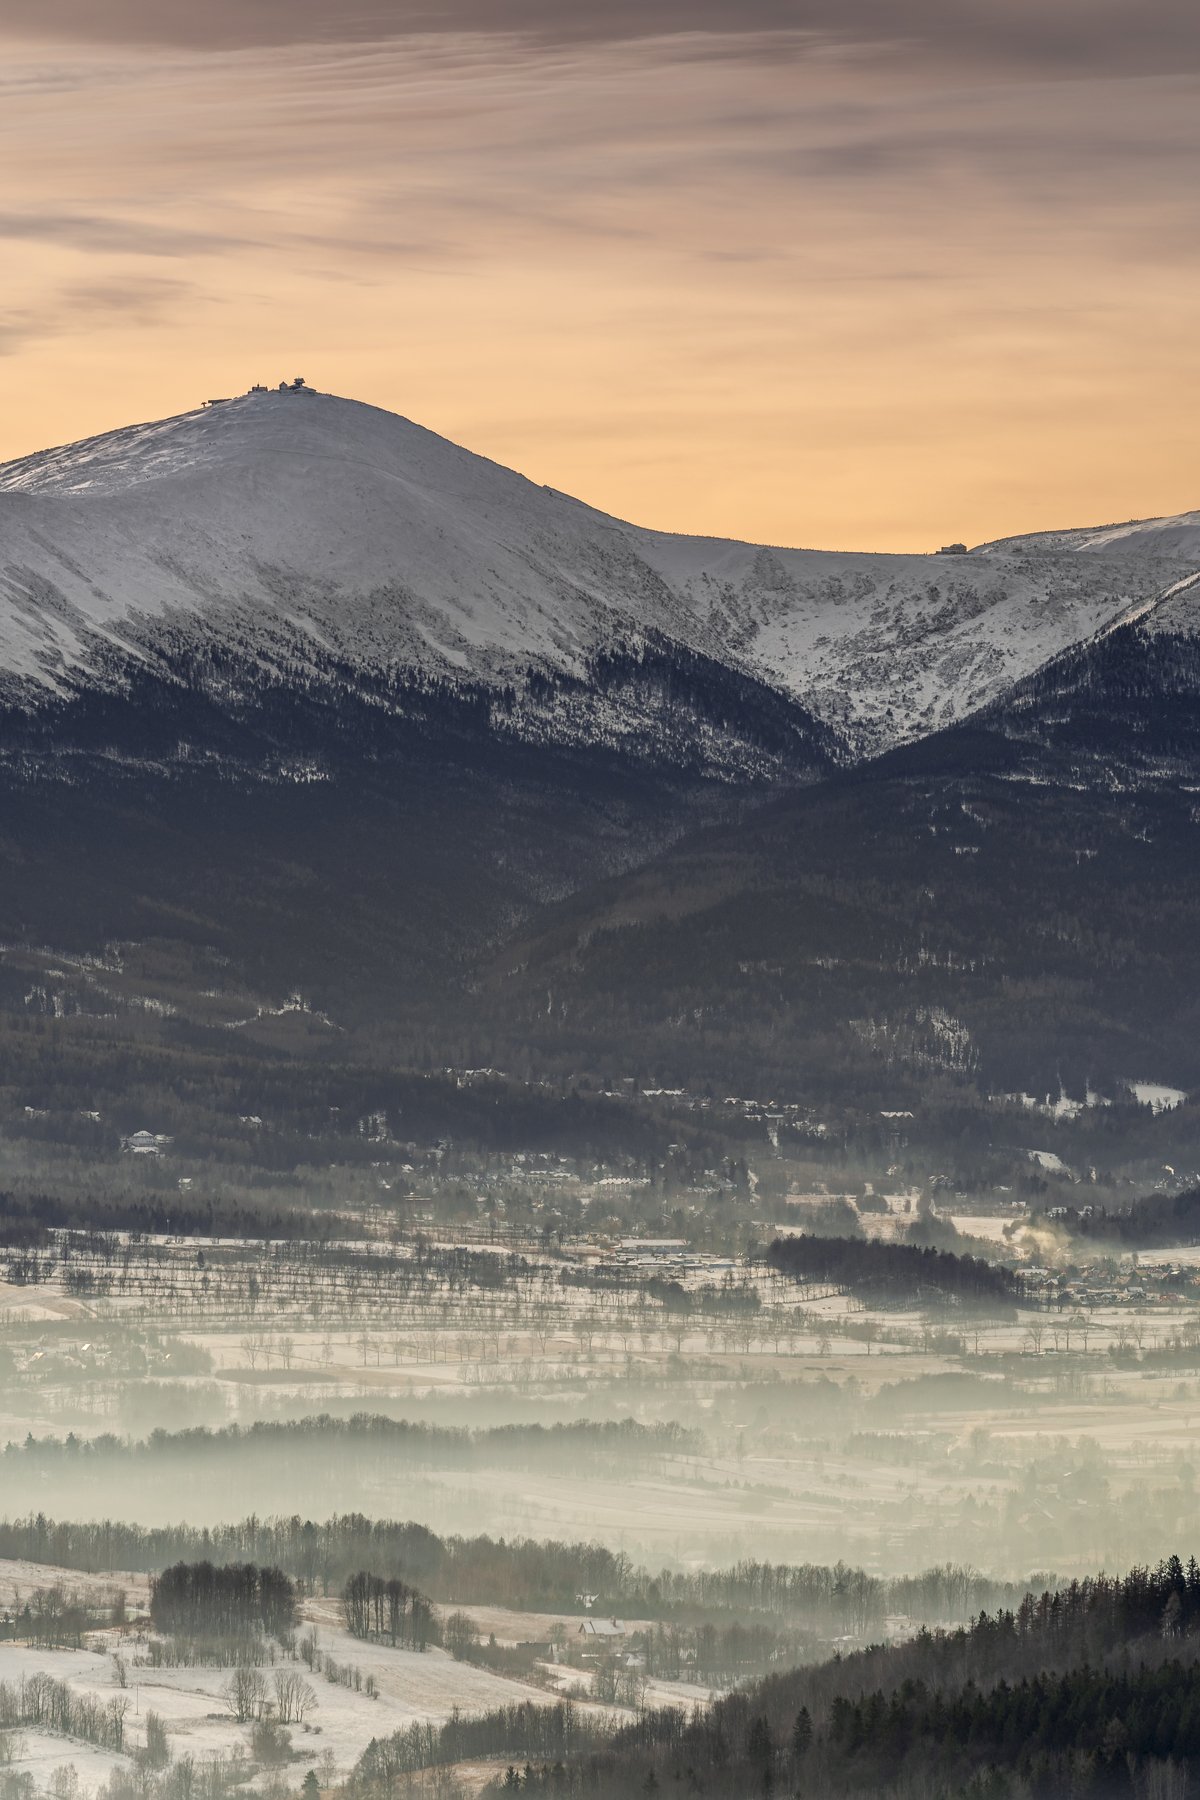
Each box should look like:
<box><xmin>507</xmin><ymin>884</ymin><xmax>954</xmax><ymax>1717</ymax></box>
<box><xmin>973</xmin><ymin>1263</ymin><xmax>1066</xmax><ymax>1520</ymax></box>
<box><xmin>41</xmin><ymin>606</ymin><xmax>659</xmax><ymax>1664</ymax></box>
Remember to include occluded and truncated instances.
<box><xmin>0</xmin><ymin>389</ymin><xmax>1200</xmax><ymax>1080</ymax></box>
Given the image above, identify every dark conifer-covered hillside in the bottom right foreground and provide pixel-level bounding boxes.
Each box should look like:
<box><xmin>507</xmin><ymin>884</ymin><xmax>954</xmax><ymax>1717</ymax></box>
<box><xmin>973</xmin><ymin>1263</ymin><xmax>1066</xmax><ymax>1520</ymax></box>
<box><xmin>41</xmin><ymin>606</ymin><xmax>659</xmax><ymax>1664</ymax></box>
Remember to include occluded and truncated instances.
<box><xmin>521</xmin><ymin>1557</ymin><xmax>1200</xmax><ymax>1800</ymax></box>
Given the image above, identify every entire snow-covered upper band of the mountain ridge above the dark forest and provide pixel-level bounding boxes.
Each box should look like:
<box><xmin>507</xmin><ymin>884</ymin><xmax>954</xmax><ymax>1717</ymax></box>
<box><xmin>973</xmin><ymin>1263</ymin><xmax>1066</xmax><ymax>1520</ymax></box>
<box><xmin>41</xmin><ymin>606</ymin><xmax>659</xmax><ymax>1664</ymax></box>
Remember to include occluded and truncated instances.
<box><xmin>0</xmin><ymin>391</ymin><xmax>1200</xmax><ymax>751</ymax></box>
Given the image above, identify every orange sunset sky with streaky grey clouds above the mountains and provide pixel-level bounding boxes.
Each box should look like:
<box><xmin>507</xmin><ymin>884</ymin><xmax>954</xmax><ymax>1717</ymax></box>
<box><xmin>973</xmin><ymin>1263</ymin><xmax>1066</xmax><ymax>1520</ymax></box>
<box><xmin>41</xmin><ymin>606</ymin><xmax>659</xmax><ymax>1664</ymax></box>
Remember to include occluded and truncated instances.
<box><xmin>0</xmin><ymin>0</ymin><xmax>1200</xmax><ymax>549</ymax></box>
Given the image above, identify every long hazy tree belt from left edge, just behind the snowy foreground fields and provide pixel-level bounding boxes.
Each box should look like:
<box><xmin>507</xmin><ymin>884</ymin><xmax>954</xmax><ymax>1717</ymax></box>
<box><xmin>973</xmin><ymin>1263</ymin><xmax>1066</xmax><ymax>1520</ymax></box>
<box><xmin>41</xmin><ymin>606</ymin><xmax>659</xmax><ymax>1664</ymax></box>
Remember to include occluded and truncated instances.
<box><xmin>0</xmin><ymin>1512</ymin><xmax>1047</xmax><ymax>1633</ymax></box>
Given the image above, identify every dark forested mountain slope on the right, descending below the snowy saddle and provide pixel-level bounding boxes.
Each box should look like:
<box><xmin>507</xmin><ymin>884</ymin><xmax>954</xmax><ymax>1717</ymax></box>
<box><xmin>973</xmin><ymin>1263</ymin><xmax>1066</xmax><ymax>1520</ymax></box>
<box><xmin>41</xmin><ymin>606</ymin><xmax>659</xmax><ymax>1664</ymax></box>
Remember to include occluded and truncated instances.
<box><xmin>491</xmin><ymin>626</ymin><xmax>1200</xmax><ymax>1098</ymax></box>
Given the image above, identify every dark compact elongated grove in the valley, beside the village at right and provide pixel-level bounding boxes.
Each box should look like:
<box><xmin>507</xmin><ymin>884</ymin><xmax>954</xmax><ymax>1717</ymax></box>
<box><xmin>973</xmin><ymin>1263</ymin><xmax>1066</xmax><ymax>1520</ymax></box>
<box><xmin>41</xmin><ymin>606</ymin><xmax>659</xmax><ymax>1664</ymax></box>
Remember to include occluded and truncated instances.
<box><xmin>766</xmin><ymin>1235</ymin><xmax>1022</xmax><ymax>1305</ymax></box>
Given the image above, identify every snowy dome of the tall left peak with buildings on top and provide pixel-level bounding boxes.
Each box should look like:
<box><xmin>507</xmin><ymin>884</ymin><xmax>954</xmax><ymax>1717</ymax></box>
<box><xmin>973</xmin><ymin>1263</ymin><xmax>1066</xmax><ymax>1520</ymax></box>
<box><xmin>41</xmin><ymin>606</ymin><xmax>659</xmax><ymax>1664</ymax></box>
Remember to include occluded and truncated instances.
<box><xmin>0</xmin><ymin>392</ymin><xmax>712</xmax><ymax>680</ymax></box>
